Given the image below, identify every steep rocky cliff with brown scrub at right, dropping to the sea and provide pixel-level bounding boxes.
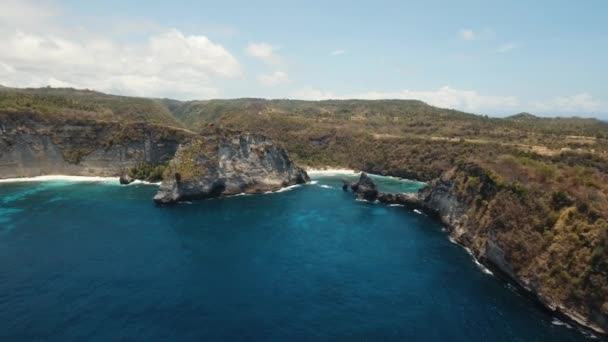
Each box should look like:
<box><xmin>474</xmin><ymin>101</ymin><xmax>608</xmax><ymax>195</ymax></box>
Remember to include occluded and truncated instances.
<box><xmin>418</xmin><ymin>163</ymin><xmax>608</xmax><ymax>333</ymax></box>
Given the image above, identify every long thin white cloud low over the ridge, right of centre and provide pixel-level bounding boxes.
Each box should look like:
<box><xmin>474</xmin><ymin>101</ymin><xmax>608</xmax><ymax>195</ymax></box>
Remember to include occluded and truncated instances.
<box><xmin>293</xmin><ymin>86</ymin><xmax>520</xmax><ymax>113</ymax></box>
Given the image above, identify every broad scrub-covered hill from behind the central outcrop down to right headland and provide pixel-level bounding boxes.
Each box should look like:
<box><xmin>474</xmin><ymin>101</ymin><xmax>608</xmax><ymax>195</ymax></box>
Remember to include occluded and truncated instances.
<box><xmin>156</xmin><ymin>95</ymin><xmax>608</xmax><ymax>331</ymax></box>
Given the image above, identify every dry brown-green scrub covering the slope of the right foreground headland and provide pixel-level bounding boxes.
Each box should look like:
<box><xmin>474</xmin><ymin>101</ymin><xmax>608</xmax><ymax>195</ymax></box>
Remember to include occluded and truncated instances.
<box><xmin>446</xmin><ymin>159</ymin><xmax>608</xmax><ymax>328</ymax></box>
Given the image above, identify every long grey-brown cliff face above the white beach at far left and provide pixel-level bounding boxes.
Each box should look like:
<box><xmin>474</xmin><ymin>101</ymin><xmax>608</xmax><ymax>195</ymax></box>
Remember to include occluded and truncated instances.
<box><xmin>0</xmin><ymin>113</ymin><xmax>189</xmax><ymax>178</ymax></box>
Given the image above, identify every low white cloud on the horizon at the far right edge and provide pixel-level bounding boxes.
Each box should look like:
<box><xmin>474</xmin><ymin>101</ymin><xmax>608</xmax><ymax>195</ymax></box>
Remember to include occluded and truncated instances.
<box><xmin>530</xmin><ymin>93</ymin><xmax>608</xmax><ymax>114</ymax></box>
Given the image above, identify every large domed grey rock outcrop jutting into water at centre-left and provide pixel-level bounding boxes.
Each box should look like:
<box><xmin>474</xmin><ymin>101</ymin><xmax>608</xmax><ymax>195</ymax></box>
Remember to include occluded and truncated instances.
<box><xmin>154</xmin><ymin>132</ymin><xmax>310</xmax><ymax>204</ymax></box>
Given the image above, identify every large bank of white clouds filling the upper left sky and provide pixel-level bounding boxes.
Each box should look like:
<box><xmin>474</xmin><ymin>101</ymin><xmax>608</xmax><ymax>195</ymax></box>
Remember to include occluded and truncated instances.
<box><xmin>0</xmin><ymin>1</ymin><xmax>241</xmax><ymax>99</ymax></box>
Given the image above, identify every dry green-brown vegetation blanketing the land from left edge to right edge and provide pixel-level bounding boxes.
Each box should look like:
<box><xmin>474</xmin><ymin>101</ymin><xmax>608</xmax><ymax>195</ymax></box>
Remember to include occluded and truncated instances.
<box><xmin>0</xmin><ymin>88</ymin><xmax>608</xmax><ymax>332</ymax></box>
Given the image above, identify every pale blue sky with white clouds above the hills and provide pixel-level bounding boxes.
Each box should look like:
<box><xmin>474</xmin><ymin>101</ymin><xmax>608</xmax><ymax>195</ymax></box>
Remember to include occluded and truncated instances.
<box><xmin>0</xmin><ymin>0</ymin><xmax>608</xmax><ymax>119</ymax></box>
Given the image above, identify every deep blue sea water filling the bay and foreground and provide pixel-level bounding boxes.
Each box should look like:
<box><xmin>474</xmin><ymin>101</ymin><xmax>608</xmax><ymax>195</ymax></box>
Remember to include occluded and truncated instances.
<box><xmin>0</xmin><ymin>177</ymin><xmax>584</xmax><ymax>341</ymax></box>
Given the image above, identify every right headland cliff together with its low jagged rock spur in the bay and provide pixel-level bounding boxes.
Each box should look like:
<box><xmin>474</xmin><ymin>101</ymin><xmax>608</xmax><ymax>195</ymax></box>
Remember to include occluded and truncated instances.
<box><xmin>344</xmin><ymin>163</ymin><xmax>608</xmax><ymax>334</ymax></box>
